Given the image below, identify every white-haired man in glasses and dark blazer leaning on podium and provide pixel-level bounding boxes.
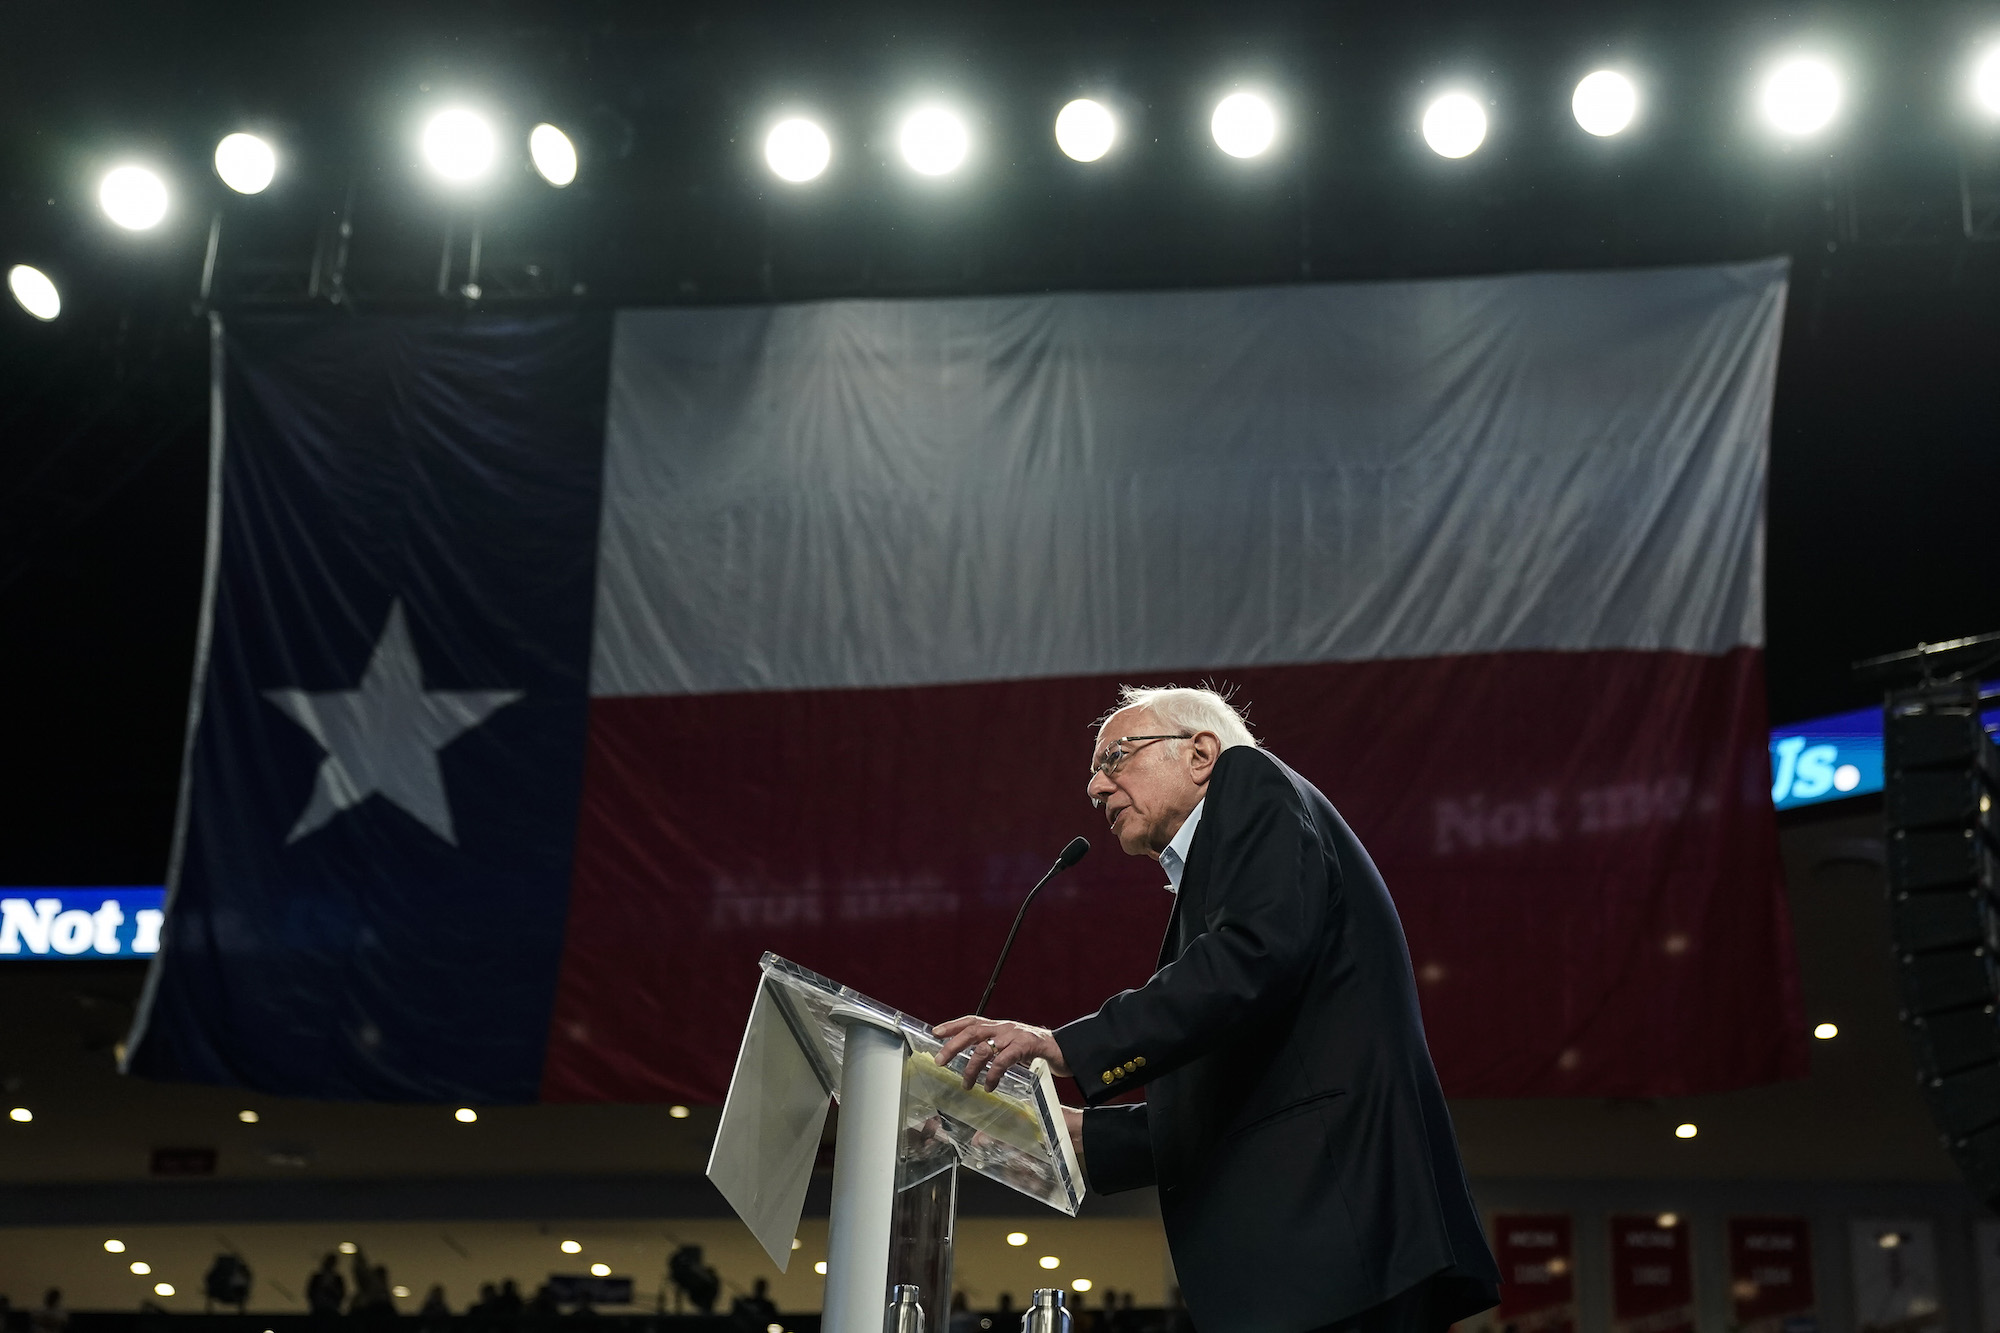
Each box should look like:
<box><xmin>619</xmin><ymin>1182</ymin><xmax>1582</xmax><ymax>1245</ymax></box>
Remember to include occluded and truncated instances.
<box><xmin>936</xmin><ymin>689</ymin><xmax>1498</xmax><ymax>1333</ymax></box>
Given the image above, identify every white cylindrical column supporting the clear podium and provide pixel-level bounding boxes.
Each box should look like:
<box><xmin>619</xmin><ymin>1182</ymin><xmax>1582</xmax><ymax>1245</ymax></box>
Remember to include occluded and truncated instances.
<box><xmin>820</xmin><ymin>1009</ymin><xmax>904</xmax><ymax>1333</ymax></box>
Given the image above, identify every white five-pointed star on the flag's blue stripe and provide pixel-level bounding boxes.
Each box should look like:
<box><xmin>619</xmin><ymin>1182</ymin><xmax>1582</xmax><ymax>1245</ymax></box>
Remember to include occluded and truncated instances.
<box><xmin>264</xmin><ymin>598</ymin><xmax>522</xmax><ymax>847</ymax></box>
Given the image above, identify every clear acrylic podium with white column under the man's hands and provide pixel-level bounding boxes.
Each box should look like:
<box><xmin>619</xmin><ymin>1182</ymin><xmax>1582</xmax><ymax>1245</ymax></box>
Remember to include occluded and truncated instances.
<box><xmin>708</xmin><ymin>953</ymin><xmax>1084</xmax><ymax>1333</ymax></box>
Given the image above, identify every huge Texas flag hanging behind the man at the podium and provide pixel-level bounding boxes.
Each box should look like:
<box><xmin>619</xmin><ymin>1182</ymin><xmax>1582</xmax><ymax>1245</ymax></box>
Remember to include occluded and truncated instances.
<box><xmin>130</xmin><ymin>262</ymin><xmax>1804</xmax><ymax>1101</ymax></box>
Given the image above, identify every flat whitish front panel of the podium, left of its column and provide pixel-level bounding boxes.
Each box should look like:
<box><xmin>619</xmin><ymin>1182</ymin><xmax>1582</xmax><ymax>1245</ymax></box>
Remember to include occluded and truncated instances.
<box><xmin>708</xmin><ymin>981</ymin><xmax>832</xmax><ymax>1273</ymax></box>
